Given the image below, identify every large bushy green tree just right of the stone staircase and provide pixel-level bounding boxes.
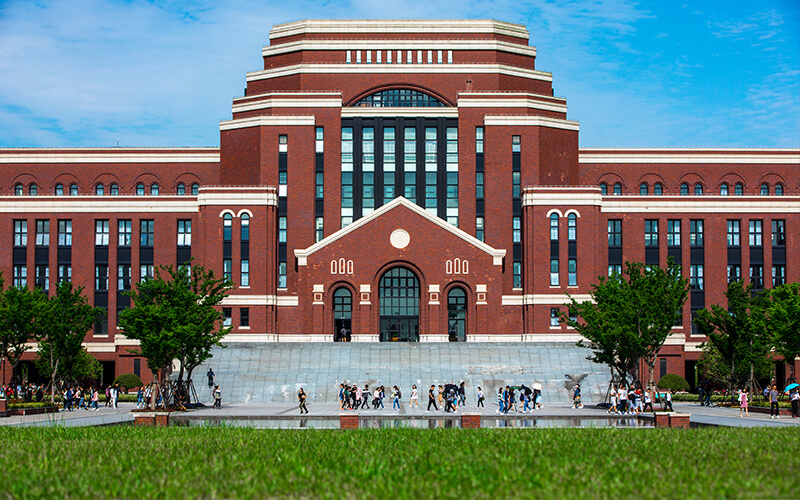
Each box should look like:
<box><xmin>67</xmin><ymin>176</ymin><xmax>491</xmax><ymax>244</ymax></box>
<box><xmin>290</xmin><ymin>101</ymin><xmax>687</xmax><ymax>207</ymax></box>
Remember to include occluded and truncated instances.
<box><xmin>561</xmin><ymin>259</ymin><xmax>689</xmax><ymax>386</ymax></box>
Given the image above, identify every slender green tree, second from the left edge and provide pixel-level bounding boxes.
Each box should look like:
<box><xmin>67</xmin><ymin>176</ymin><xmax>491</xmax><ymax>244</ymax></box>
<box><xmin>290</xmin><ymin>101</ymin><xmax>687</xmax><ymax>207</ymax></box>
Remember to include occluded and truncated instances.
<box><xmin>38</xmin><ymin>281</ymin><xmax>103</xmax><ymax>403</ymax></box>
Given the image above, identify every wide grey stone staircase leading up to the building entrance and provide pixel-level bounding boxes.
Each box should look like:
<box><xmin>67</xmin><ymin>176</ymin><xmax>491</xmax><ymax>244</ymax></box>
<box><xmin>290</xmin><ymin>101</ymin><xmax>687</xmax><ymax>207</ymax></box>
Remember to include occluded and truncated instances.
<box><xmin>188</xmin><ymin>342</ymin><xmax>609</xmax><ymax>405</ymax></box>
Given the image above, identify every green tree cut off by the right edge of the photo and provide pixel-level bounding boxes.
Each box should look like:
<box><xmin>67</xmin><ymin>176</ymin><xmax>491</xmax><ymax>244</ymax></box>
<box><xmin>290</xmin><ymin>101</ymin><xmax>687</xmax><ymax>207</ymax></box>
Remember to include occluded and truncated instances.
<box><xmin>767</xmin><ymin>283</ymin><xmax>800</xmax><ymax>382</ymax></box>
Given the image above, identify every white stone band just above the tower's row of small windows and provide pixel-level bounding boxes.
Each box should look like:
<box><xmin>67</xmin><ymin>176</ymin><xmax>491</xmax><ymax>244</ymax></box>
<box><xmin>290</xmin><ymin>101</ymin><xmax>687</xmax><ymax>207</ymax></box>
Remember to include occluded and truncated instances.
<box><xmin>261</xmin><ymin>39</ymin><xmax>536</xmax><ymax>58</ymax></box>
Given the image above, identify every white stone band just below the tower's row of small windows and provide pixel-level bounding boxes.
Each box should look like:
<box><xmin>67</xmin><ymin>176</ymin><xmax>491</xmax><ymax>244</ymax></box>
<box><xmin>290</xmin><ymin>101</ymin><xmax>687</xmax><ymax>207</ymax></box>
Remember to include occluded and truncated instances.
<box><xmin>247</xmin><ymin>63</ymin><xmax>553</xmax><ymax>83</ymax></box>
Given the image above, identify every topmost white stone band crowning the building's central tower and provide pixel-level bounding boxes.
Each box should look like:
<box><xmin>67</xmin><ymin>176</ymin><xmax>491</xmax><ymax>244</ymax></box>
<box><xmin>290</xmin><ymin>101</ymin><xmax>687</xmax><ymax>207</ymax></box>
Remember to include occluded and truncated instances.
<box><xmin>269</xmin><ymin>19</ymin><xmax>529</xmax><ymax>40</ymax></box>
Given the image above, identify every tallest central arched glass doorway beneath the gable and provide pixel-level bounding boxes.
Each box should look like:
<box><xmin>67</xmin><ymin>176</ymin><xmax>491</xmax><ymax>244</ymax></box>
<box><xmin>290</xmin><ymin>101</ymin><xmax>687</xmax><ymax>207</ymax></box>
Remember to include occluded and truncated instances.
<box><xmin>380</xmin><ymin>267</ymin><xmax>419</xmax><ymax>342</ymax></box>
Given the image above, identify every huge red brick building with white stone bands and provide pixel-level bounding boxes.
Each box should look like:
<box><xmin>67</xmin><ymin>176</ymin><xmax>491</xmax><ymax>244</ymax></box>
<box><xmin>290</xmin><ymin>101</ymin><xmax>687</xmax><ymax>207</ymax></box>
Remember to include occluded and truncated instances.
<box><xmin>0</xmin><ymin>21</ymin><xmax>800</xmax><ymax>386</ymax></box>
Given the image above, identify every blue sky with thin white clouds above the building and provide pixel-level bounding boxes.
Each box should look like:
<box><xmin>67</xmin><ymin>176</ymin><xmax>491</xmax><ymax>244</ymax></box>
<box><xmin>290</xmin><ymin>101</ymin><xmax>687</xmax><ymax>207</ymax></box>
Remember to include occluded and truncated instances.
<box><xmin>0</xmin><ymin>0</ymin><xmax>800</xmax><ymax>148</ymax></box>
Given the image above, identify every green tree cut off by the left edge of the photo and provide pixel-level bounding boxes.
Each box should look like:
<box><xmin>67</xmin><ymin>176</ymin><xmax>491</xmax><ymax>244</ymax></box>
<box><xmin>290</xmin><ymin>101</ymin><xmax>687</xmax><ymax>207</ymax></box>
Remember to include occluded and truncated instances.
<box><xmin>0</xmin><ymin>276</ymin><xmax>47</xmax><ymax>383</ymax></box>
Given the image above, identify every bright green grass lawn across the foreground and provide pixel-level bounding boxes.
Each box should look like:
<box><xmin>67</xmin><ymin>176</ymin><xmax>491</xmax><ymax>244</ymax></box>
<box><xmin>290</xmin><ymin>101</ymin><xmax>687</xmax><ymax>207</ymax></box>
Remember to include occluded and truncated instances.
<box><xmin>0</xmin><ymin>426</ymin><xmax>800</xmax><ymax>499</ymax></box>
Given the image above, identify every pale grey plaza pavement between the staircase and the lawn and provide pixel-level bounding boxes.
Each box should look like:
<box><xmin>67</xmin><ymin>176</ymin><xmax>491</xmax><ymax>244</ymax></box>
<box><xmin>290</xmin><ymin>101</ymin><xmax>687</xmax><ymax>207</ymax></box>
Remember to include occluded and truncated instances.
<box><xmin>0</xmin><ymin>398</ymin><xmax>800</xmax><ymax>427</ymax></box>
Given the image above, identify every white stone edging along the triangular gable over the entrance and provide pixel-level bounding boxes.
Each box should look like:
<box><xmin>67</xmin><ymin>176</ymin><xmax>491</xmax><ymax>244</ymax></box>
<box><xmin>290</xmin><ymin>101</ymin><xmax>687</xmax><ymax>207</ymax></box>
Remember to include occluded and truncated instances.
<box><xmin>294</xmin><ymin>196</ymin><xmax>506</xmax><ymax>266</ymax></box>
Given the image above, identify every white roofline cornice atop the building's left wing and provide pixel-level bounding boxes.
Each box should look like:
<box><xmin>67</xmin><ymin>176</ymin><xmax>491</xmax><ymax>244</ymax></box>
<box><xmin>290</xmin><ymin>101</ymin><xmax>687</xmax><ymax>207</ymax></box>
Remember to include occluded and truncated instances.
<box><xmin>0</xmin><ymin>148</ymin><xmax>219</xmax><ymax>163</ymax></box>
